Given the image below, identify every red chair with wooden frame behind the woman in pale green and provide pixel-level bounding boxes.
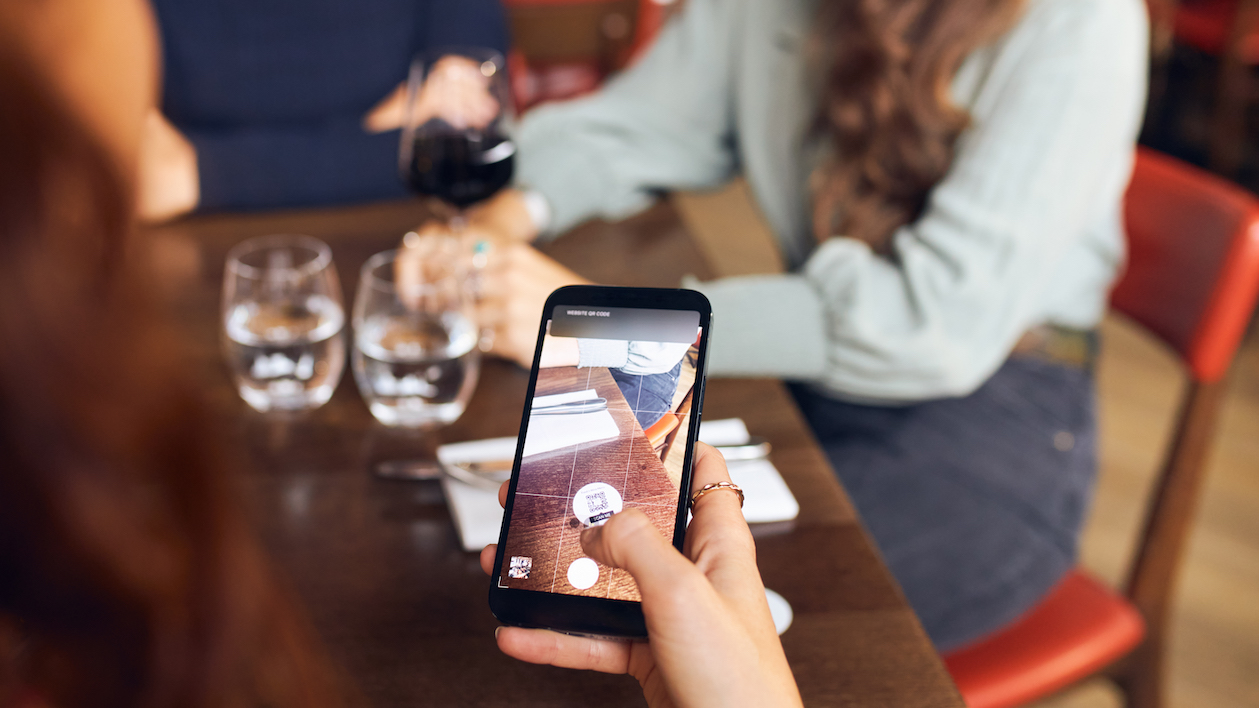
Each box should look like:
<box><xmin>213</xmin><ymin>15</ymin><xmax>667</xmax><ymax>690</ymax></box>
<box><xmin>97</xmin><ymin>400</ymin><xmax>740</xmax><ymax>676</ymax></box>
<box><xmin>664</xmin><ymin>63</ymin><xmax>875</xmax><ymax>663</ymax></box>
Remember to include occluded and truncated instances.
<box><xmin>944</xmin><ymin>149</ymin><xmax>1259</xmax><ymax>708</ymax></box>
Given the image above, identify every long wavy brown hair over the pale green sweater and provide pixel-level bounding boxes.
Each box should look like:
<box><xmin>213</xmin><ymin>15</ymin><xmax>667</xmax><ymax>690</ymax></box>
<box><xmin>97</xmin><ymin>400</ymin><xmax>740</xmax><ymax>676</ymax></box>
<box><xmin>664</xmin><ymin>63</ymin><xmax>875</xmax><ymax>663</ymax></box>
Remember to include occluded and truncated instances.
<box><xmin>812</xmin><ymin>0</ymin><xmax>1024</xmax><ymax>252</ymax></box>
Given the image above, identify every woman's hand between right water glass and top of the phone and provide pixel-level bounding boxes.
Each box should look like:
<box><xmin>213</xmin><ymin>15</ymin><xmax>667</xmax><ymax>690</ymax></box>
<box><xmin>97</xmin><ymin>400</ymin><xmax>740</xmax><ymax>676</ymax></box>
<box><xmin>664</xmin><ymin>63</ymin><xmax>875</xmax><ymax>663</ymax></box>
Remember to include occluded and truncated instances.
<box><xmin>477</xmin><ymin>242</ymin><xmax>590</xmax><ymax>368</ymax></box>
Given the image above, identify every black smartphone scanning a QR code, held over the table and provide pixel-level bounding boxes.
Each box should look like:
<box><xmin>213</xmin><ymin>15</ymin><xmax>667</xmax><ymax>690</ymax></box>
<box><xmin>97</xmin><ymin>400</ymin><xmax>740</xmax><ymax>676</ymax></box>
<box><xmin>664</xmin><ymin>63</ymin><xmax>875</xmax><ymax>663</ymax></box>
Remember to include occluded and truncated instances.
<box><xmin>490</xmin><ymin>286</ymin><xmax>713</xmax><ymax>636</ymax></box>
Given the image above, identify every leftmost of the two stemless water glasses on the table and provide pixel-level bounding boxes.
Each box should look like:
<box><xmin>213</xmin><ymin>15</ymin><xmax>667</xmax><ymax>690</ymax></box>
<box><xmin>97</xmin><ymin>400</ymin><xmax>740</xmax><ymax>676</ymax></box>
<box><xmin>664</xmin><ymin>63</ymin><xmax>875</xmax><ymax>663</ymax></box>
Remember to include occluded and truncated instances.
<box><xmin>223</xmin><ymin>234</ymin><xmax>345</xmax><ymax>411</ymax></box>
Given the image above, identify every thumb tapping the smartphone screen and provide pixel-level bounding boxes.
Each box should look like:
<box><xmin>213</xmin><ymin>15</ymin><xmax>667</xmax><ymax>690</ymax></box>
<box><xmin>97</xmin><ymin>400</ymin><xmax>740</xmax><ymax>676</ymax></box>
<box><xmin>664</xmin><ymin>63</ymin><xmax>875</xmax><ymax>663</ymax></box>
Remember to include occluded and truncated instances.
<box><xmin>582</xmin><ymin>509</ymin><xmax>699</xmax><ymax>601</ymax></box>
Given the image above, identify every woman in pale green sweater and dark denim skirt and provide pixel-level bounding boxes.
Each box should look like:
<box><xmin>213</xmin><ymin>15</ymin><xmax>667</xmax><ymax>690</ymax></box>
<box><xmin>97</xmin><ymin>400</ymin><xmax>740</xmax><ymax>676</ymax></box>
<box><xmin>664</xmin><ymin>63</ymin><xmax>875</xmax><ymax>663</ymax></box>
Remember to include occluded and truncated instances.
<box><xmin>387</xmin><ymin>0</ymin><xmax>1147</xmax><ymax>650</ymax></box>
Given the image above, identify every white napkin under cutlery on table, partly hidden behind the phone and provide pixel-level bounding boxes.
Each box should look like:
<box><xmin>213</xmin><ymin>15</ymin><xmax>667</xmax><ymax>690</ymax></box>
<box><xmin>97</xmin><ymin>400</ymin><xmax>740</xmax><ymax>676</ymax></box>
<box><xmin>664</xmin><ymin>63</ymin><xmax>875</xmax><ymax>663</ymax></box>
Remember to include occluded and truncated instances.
<box><xmin>437</xmin><ymin>411</ymin><xmax>799</xmax><ymax>551</ymax></box>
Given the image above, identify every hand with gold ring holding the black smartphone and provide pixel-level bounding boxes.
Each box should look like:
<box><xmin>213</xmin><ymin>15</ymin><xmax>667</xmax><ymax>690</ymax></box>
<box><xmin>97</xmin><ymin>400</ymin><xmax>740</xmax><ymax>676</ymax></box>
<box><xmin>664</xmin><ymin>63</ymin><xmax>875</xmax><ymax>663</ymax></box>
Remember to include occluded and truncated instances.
<box><xmin>481</xmin><ymin>443</ymin><xmax>801</xmax><ymax>707</ymax></box>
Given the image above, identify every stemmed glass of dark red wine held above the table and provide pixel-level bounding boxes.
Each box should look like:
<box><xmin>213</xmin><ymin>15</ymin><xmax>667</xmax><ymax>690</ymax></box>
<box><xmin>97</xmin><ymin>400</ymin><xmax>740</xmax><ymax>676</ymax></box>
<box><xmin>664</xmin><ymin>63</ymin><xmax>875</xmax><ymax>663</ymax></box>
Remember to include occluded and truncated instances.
<box><xmin>398</xmin><ymin>47</ymin><xmax>516</xmax><ymax>220</ymax></box>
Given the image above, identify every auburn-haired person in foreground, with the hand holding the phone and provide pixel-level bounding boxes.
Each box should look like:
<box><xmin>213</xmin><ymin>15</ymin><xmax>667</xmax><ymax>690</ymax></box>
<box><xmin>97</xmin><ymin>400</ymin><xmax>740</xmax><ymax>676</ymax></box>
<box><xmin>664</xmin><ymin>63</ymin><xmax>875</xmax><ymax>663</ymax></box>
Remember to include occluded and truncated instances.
<box><xmin>0</xmin><ymin>0</ymin><xmax>799</xmax><ymax>708</ymax></box>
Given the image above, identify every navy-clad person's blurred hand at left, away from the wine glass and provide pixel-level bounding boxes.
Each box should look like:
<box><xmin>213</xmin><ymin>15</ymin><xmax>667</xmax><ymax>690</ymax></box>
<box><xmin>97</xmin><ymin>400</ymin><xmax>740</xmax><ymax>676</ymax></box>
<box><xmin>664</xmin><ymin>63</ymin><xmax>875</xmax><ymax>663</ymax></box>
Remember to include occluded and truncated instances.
<box><xmin>136</xmin><ymin>108</ymin><xmax>201</xmax><ymax>222</ymax></box>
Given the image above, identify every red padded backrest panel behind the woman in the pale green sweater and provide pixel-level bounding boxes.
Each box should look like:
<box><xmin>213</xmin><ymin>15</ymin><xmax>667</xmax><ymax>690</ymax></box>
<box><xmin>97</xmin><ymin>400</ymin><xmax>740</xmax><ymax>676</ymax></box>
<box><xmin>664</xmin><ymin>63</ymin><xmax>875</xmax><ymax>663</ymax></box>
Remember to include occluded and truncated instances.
<box><xmin>1110</xmin><ymin>147</ymin><xmax>1259</xmax><ymax>383</ymax></box>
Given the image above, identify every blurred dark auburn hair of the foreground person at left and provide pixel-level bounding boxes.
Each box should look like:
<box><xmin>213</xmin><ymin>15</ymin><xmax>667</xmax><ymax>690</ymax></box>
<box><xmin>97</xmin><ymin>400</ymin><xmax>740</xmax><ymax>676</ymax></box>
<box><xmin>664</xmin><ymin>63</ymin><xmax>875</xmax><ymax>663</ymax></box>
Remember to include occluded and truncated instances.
<box><xmin>0</xmin><ymin>43</ymin><xmax>339</xmax><ymax>708</ymax></box>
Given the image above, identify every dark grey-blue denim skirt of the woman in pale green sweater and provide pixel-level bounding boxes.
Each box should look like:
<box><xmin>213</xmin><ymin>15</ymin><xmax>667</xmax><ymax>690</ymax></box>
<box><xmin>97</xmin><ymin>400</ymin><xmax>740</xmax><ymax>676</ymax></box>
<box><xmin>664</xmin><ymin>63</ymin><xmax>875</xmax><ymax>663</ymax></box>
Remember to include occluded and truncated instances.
<box><xmin>791</xmin><ymin>357</ymin><xmax>1097</xmax><ymax>651</ymax></box>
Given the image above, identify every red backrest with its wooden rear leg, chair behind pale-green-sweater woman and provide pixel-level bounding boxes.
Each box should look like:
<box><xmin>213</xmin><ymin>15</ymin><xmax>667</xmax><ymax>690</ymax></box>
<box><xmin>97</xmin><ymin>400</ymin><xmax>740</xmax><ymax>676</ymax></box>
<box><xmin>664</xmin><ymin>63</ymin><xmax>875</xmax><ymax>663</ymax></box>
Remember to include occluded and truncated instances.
<box><xmin>1110</xmin><ymin>149</ymin><xmax>1259</xmax><ymax>660</ymax></box>
